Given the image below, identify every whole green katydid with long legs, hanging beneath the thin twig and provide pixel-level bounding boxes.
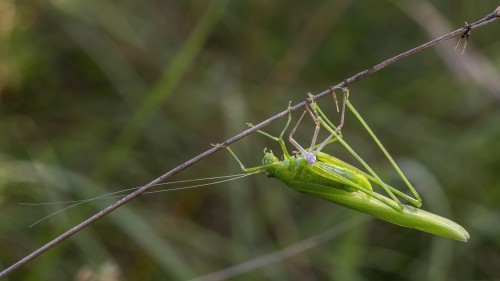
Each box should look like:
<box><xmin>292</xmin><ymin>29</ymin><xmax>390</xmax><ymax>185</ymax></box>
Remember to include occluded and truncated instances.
<box><xmin>226</xmin><ymin>89</ymin><xmax>469</xmax><ymax>242</ymax></box>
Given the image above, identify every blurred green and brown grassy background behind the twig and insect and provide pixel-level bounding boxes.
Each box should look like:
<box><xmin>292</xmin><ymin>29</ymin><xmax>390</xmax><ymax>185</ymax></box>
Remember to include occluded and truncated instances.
<box><xmin>0</xmin><ymin>0</ymin><xmax>500</xmax><ymax>280</ymax></box>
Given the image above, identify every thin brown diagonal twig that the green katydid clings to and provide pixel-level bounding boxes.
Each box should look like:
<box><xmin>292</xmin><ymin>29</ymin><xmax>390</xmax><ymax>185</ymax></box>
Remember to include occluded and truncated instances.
<box><xmin>0</xmin><ymin>7</ymin><xmax>500</xmax><ymax>278</ymax></box>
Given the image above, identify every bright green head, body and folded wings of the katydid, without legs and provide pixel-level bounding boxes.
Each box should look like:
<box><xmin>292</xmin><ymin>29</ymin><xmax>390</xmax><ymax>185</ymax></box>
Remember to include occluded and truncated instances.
<box><xmin>264</xmin><ymin>152</ymin><xmax>469</xmax><ymax>242</ymax></box>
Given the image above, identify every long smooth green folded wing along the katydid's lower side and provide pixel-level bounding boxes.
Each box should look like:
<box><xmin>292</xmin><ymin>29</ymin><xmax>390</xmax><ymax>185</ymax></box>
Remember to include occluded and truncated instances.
<box><xmin>288</xmin><ymin>182</ymin><xmax>469</xmax><ymax>242</ymax></box>
